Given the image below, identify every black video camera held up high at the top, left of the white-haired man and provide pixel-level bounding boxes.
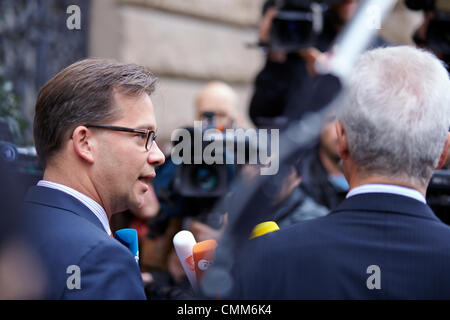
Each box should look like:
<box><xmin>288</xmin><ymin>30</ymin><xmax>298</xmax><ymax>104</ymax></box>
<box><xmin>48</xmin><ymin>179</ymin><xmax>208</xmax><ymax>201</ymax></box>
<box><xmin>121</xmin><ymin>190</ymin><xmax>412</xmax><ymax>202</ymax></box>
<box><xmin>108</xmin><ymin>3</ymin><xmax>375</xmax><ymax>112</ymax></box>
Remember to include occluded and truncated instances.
<box><xmin>269</xmin><ymin>0</ymin><xmax>338</xmax><ymax>52</ymax></box>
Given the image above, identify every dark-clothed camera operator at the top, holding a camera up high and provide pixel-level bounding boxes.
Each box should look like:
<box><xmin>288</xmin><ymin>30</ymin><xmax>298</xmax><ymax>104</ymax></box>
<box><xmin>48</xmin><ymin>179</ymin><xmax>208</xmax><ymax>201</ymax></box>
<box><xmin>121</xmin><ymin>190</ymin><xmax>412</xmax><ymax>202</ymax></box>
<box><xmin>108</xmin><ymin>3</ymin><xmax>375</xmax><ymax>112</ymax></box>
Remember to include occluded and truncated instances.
<box><xmin>249</xmin><ymin>0</ymin><xmax>387</xmax><ymax>129</ymax></box>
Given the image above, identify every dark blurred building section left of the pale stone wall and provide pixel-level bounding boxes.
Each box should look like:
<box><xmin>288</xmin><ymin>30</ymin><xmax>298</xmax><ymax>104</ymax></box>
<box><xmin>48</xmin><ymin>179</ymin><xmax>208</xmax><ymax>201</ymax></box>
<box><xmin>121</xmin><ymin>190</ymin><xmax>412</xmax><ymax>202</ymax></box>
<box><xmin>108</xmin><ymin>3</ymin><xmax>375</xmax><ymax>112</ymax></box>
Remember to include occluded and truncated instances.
<box><xmin>0</xmin><ymin>0</ymin><xmax>91</xmax><ymax>146</ymax></box>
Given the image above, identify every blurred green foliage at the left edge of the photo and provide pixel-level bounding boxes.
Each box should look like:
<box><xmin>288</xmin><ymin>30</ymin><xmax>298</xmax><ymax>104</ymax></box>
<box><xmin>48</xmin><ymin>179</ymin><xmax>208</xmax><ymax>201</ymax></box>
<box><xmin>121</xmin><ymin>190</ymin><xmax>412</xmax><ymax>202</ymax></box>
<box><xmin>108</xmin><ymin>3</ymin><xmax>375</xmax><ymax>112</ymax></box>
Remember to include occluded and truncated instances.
<box><xmin>0</xmin><ymin>64</ymin><xmax>28</xmax><ymax>144</ymax></box>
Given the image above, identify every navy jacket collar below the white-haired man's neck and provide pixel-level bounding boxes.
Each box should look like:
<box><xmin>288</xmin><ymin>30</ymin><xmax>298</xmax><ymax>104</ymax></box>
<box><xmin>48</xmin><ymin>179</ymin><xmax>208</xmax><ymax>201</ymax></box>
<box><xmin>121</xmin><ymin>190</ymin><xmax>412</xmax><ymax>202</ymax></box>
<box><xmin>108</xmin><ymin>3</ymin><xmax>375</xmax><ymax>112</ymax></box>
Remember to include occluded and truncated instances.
<box><xmin>331</xmin><ymin>193</ymin><xmax>440</xmax><ymax>221</ymax></box>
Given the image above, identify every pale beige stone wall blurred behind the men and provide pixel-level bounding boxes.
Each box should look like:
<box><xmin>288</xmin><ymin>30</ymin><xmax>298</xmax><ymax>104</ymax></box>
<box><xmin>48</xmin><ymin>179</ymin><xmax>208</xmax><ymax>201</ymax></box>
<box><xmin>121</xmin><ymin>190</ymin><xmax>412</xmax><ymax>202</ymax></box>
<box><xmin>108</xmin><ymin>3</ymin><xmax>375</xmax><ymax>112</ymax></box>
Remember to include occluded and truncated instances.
<box><xmin>89</xmin><ymin>0</ymin><xmax>421</xmax><ymax>150</ymax></box>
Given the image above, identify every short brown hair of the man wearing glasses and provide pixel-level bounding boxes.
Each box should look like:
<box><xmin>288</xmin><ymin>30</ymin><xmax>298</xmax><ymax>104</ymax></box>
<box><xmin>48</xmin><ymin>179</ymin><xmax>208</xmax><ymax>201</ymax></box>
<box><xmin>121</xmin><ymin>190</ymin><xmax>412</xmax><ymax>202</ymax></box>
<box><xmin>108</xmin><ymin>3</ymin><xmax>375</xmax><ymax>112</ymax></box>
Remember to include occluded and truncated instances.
<box><xmin>33</xmin><ymin>59</ymin><xmax>156</xmax><ymax>166</ymax></box>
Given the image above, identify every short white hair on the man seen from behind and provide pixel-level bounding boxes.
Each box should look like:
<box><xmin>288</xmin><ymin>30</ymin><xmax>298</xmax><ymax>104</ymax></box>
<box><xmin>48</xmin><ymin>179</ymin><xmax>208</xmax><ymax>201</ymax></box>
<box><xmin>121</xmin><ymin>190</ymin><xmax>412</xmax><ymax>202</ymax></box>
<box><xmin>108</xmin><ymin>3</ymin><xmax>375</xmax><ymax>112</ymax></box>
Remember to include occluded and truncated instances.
<box><xmin>337</xmin><ymin>46</ymin><xmax>450</xmax><ymax>186</ymax></box>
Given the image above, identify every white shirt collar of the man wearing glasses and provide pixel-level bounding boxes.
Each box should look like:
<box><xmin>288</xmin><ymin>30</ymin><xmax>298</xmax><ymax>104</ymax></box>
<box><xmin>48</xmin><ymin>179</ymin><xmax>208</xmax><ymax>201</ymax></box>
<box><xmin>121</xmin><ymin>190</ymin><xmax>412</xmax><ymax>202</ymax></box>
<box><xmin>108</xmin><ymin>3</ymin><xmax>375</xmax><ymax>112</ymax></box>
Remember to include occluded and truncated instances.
<box><xmin>37</xmin><ymin>180</ymin><xmax>111</xmax><ymax>235</ymax></box>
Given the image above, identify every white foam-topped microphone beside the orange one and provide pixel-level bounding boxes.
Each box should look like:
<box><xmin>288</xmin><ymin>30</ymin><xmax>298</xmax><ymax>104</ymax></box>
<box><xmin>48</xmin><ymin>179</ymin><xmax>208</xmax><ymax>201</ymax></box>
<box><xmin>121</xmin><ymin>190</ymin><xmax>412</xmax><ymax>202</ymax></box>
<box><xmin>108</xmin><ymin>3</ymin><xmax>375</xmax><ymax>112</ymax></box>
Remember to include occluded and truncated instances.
<box><xmin>173</xmin><ymin>230</ymin><xmax>197</xmax><ymax>289</ymax></box>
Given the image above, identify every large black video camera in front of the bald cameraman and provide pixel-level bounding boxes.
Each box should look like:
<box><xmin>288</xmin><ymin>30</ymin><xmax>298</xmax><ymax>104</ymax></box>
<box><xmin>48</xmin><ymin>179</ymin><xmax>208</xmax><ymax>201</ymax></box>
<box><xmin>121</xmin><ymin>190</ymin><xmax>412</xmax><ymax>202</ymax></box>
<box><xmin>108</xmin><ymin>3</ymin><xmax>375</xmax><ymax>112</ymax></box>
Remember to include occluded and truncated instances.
<box><xmin>153</xmin><ymin>112</ymin><xmax>258</xmax><ymax>228</ymax></box>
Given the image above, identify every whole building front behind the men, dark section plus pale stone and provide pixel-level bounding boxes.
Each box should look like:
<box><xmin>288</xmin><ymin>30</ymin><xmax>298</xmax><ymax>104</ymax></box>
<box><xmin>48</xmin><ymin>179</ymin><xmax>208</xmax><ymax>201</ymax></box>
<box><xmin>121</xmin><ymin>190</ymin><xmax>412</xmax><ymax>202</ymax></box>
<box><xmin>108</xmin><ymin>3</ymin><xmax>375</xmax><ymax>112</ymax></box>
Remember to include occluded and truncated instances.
<box><xmin>0</xmin><ymin>0</ymin><xmax>422</xmax><ymax>148</ymax></box>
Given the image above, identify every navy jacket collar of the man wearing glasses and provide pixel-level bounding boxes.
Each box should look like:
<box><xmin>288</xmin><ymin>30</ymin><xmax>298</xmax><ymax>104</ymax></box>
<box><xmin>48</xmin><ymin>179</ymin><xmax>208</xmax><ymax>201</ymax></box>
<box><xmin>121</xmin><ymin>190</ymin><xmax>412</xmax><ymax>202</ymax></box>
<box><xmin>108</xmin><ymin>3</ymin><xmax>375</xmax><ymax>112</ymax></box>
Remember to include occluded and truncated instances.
<box><xmin>25</xmin><ymin>186</ymin><xmax>105</xmax><ymax>232</ymax></box>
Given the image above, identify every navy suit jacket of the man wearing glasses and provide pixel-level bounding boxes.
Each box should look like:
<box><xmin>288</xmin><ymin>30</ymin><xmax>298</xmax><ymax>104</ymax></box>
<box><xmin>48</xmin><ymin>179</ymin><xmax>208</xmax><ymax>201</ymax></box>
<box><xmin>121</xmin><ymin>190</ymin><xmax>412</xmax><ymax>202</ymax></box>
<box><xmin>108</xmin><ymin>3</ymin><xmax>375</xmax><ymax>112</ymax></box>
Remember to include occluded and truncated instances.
<box><xmin>24</xmin><ymin>186</ymin><xmax>145</xmax><ymax>299</ymax></box>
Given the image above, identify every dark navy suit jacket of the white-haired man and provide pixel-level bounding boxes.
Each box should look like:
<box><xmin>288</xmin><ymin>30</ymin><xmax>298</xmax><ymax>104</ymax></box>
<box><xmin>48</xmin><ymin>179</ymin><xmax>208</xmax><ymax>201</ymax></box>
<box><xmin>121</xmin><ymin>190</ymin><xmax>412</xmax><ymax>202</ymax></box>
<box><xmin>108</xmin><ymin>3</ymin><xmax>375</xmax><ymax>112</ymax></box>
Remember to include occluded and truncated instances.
<box><xmin>232</xmin><ymin>193</ymin><xmax>450</xmax><ymax>299</ymax></box>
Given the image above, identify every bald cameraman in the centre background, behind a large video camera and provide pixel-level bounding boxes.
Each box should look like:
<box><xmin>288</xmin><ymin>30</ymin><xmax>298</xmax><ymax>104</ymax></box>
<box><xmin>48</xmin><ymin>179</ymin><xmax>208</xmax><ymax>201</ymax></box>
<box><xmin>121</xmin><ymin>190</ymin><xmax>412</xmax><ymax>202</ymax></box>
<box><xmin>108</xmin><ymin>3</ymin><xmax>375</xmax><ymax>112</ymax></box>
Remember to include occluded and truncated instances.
<box><xmin>142</xmin><ymin>80</ymin><xmax>243</xmax><ymax>299</ymax></box>
